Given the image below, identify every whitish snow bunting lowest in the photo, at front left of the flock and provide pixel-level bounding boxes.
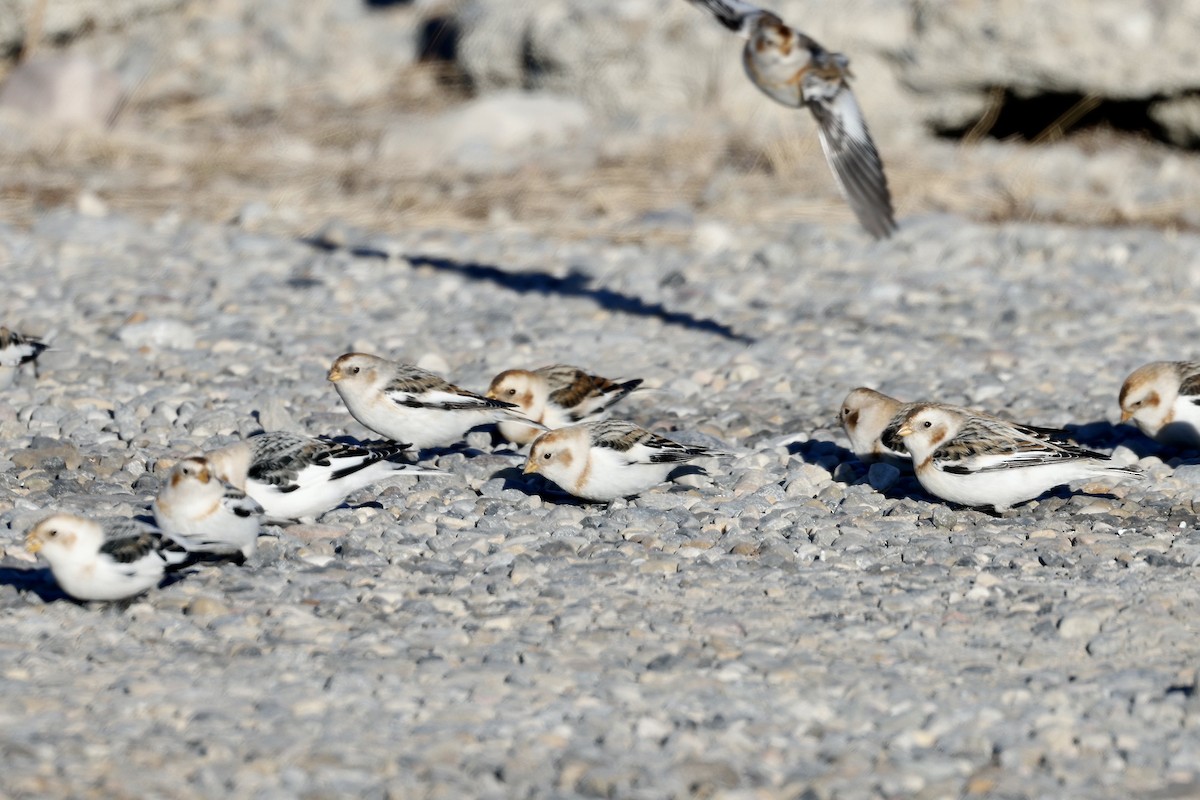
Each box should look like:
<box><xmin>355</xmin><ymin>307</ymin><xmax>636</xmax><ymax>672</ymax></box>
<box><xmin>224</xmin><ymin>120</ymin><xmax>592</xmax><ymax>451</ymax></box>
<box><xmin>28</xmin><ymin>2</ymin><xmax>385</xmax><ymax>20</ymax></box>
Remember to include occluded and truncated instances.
<box><xmin>25</xmin><ymin>513</ymin><xmax>190</xmax><ymax>600</ymax></box>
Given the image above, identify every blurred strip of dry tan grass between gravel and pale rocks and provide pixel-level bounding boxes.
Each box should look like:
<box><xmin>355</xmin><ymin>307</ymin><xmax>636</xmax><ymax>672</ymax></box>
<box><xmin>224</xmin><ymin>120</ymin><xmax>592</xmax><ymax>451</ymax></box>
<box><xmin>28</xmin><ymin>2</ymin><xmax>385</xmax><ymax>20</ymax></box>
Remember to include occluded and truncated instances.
<box><xmin>0</xmin><ymin>50</ymin><xmax>1195</xmax><ymax>242</ymax></box>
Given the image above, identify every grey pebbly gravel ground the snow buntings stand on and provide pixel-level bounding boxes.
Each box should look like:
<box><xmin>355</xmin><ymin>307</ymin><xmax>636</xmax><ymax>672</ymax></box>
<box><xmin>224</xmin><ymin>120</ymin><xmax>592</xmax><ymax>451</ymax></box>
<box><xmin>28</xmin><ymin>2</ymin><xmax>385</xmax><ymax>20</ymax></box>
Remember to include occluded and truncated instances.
<box><xmin>0</xmin><ymin>211</ymin><xmax>1200</xmax><ymax>800</ymax></box>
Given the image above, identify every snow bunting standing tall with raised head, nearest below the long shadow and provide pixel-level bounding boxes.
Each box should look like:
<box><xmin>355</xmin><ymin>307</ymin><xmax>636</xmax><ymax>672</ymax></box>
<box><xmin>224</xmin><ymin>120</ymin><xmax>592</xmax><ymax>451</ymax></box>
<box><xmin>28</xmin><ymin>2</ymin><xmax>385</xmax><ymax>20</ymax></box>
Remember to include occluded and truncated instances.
<box><xmin>328</xmin><ymin>353</ymin><xmax>546</xmax><ymax>450</ymax></box>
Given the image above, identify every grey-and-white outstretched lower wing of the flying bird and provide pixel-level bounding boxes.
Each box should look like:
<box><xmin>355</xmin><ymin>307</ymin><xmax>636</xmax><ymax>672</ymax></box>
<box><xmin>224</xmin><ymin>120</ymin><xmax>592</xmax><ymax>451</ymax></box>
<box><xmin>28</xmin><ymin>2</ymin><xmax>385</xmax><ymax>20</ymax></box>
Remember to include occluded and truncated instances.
<box><xmin>803</xmin><ymin>65</ymin><xmax>896</xmax><ymax>239</ymax></box>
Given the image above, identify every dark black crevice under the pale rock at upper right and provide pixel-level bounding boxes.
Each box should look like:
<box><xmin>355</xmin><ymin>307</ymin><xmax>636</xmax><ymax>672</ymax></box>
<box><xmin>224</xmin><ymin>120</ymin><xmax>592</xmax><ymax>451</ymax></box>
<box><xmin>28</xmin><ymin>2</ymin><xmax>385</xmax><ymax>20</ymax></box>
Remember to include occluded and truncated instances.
<box><xmin>934</xmin><ymin>88</ymin><xmax>1180</xmax><ymax>149</ymax></box>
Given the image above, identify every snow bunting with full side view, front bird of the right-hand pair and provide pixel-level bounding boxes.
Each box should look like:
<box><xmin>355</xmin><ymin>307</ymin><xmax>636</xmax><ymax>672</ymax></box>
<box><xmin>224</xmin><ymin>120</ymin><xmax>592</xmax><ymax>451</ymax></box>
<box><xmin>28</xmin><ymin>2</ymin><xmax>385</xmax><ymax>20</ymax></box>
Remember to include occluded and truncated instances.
<box><xmin>883</xmin><ymin>403</ymin><xmax>1140</xmax><ymax>511</ymax></box>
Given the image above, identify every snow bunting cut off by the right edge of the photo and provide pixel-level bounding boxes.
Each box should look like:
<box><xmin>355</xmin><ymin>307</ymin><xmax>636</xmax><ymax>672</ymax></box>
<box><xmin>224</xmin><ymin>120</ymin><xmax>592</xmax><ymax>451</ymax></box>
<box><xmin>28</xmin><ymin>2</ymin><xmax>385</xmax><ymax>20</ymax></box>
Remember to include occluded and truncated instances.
<box><xmin>1120</xmin><ymin>361</ymin><xmax>1200</xmax><ymax>447</ymax></box>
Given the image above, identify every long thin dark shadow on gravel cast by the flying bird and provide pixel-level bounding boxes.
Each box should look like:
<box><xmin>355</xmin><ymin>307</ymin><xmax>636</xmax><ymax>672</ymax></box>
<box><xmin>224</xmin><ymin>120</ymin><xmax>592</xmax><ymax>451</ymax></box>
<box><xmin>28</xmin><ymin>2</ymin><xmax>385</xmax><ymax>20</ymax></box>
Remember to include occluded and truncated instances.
<box><xmin>300</xmin><ymin>237</ymin><xmax>755</xmax><ymax>344</ymax></box>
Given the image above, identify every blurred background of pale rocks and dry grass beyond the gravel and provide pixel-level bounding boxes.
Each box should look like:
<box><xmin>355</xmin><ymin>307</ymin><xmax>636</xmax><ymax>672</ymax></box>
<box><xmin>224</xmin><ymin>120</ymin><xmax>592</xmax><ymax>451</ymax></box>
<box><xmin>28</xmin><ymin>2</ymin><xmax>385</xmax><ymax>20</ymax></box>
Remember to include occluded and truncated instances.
<box><xmin>0</xmin><ymin>0</ymin><xmax>1200</xmax><ymax>241</ymax></box>
